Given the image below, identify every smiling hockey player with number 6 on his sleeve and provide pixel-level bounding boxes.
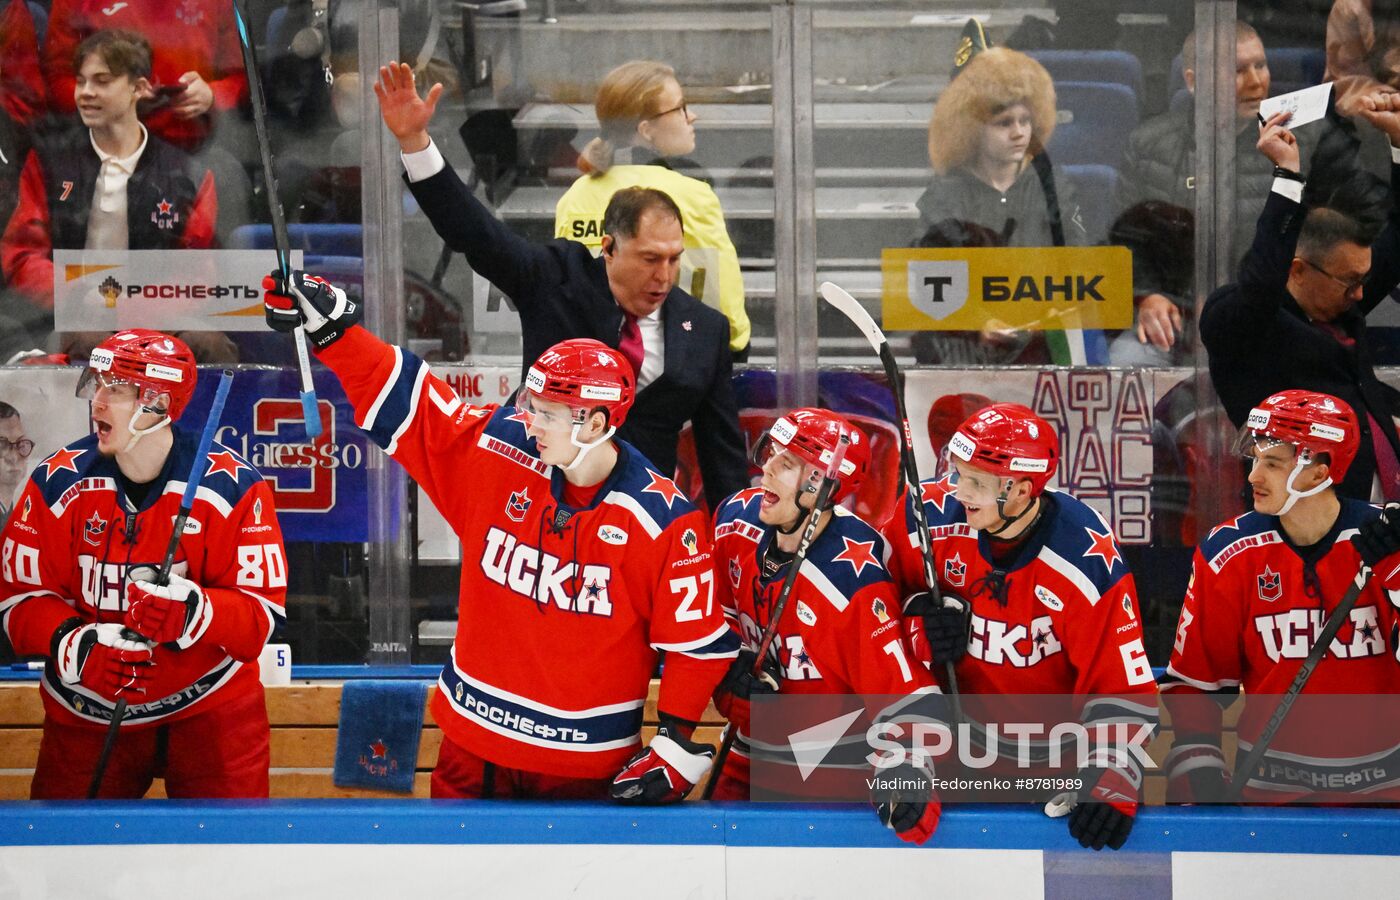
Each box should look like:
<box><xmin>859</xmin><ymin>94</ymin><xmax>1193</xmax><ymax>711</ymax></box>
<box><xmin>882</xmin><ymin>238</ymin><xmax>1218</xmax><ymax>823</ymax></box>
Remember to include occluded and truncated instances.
<box><xmin>885</xmin><ymin>403</ymin><xmax>1156</xmax><ymax>850</ymax></box>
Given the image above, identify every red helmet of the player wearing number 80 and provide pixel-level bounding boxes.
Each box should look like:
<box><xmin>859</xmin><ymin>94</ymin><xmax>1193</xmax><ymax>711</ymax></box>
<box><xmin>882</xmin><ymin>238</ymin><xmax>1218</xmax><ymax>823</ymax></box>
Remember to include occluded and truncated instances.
<box><xmin>77</xmin><ymin>328</ymin><xmax>199</xmax><ymax>421</ymax></box>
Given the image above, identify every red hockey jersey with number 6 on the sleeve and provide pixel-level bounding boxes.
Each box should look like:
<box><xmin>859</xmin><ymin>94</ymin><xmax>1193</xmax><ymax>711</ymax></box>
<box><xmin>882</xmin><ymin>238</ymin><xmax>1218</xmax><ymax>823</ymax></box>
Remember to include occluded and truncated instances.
<box><xmin>885</xmin><ymin>479</ymin><xmax>1158</xmax><ymax>775</ymax></box>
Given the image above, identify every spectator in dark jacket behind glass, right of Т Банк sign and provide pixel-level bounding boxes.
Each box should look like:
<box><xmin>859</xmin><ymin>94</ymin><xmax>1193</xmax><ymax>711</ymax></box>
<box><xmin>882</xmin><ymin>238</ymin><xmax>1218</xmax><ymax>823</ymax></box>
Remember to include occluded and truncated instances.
<box><xmin>1110</xmin><ymin>22</ymin><xmax>1273</xmax><ymax>365</ymax></box>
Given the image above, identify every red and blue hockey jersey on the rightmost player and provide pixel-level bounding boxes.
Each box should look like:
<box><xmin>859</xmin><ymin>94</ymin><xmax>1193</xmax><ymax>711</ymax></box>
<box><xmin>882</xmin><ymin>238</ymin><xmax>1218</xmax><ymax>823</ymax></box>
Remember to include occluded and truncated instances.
<box><xmin>1162</xmin><ymin>500</ymin><xmax>1400</xmax><ymax>802</ymax></box>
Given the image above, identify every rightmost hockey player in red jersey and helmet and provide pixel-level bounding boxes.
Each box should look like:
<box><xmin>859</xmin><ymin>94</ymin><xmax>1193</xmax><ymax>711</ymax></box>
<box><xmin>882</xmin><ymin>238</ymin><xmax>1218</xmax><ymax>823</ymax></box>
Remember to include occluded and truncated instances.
<box><xmin>1162</xmin><ymin>391</ymin><xmax>1400</xmax><ymax>802</ymax></box>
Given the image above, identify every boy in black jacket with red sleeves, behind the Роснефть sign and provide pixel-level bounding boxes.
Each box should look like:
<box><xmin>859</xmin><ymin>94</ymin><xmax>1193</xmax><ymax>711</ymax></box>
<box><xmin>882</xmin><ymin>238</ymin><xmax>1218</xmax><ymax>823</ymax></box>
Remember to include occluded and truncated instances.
<box><xmin>0</xmin><ymin>31</ymin><xmax>217</xmax><ymax>338</ymax></box>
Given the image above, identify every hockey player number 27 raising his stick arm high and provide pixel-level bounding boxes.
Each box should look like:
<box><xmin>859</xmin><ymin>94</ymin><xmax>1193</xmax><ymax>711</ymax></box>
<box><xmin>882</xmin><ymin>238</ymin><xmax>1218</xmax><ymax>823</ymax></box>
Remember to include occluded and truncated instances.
<box><xmin>266</xmin><ymin>273</ymin><xmax>738</xmax><ymax>803</ymax></box>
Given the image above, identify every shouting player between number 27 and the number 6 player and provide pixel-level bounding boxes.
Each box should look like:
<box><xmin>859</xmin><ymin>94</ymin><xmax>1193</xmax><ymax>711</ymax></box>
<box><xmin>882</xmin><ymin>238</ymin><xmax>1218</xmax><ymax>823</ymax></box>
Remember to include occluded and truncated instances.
<box><xmin>714</xmin><ymin>409</ymin><xmax>941</xmax><ymax>843</ymax></box>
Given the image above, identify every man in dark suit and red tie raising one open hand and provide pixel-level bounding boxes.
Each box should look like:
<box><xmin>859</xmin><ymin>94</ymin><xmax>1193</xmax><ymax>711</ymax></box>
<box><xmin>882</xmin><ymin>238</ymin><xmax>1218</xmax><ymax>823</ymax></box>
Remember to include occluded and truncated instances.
<box><xmin>374</xmin><ymin>63</ymin><xmax>749</xmax><ymax>509</ymax></box>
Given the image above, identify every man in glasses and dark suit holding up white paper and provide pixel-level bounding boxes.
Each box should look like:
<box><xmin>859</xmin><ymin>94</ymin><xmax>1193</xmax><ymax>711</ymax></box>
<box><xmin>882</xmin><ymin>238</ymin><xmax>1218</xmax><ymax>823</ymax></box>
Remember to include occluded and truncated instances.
<box><xmin>1201</xmin><ymin>94</ymin><xmax>1400</xmax><ymax>500</ymax></box>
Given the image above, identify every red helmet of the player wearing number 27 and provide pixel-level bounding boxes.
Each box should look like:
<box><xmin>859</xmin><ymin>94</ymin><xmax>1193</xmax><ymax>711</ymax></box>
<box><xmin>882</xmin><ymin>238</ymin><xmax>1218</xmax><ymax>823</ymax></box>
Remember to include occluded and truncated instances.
<box><xmin>525</xmin><ymin>337</ymin><xmax>637</xmax><ymax>428</ymax></box>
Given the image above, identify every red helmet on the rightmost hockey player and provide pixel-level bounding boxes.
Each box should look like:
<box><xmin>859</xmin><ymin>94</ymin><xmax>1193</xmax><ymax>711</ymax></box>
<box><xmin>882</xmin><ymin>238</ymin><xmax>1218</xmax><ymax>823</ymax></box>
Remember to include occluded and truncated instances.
<box><xmin>1235</xmin><ymin>391</ymin><xmax>1361</xmax><ymax>483</ymax></box>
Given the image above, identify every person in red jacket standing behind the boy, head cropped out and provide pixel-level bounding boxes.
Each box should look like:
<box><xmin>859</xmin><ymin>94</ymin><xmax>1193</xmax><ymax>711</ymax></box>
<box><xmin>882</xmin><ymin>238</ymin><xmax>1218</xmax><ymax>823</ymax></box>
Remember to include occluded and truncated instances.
<box><xmin>43</xmin><ymin>0</ymin><xmax>248</xmax><ymax>153</ymax></box>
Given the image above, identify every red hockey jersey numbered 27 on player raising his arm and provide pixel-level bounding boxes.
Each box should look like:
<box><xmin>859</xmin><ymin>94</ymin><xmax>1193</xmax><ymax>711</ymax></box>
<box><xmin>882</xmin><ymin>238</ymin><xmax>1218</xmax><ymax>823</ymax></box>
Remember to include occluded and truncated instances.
<box><xmin>319</xmin><ymin>328</ymin><xmax>739</xmax><ymax>778</ymax></box>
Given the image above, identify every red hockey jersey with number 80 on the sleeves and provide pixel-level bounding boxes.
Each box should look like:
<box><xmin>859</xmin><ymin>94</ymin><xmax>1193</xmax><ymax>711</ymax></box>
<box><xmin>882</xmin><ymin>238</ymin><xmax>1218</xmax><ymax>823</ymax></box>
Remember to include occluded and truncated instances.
<box><xmin>0</xmin><ymin>427</ymin><xmax>287</xmax><ymax>728</ymax></box>
